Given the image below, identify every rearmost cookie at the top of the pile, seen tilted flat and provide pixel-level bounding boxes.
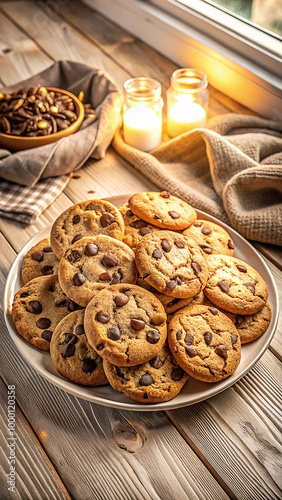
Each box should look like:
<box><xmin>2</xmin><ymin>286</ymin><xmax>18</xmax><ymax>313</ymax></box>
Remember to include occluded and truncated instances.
<box><xmin>128</xmin><ymin>191</ymin><xmax>197</xmax><ymax>230</ymax></box>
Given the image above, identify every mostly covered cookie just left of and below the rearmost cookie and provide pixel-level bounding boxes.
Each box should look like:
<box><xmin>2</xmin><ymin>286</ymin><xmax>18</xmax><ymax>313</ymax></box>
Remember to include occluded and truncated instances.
<box><xmin>119</xmin><ymin>203</ymin><xmax>160</xmax><ymax>251</ymax></box>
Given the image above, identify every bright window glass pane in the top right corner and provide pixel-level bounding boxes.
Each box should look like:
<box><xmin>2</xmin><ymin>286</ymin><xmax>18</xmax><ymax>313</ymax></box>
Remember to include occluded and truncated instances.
<box><xmin>178</xmin><ymin>0</ymin><xmax>282</xmax><ymax>38</ymax></box>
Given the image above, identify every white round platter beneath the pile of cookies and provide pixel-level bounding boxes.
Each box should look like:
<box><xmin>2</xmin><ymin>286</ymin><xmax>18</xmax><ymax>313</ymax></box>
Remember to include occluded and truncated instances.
<box><xmin>4</xmin><ymin>196</ymin><xmax>279</xmax><ymax>411</ymax></box>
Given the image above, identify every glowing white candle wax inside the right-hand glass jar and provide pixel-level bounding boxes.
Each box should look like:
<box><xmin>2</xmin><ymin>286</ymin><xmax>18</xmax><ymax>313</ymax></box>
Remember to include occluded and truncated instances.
<box><xmin>167</xmin><ymin>96</ymin><xmax>206</xmax><ymax>137</ymax></box>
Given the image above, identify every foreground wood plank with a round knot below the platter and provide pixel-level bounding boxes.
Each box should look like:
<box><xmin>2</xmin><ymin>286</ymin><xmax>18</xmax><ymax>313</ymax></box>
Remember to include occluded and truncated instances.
<box><xmin>0</xmin><ymin>238</ymin><xmax>228</xmax><ymax>500</ymax></box>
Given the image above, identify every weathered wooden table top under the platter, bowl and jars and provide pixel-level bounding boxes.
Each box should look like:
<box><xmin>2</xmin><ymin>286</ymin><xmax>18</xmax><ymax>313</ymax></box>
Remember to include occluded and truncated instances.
<box><xmin>0</xmin><ymin>0</ymin><xmax>282</xmax><ymax>500</ymax></box>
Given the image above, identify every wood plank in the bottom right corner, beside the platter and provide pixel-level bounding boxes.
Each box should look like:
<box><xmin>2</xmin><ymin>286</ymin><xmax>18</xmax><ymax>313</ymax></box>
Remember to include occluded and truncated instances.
<box><xmin>166</xmin><ymin>351</ymin><xmax>282</xmax><ymax>500</ymax></box>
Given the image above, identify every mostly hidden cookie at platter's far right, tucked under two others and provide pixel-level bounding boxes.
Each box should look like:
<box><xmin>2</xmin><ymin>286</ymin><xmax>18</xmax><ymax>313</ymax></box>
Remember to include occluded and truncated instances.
<box><xmin>226</xmin><ymin>304</ymin><xmax>271</xmax><ymax>344</ymax></box>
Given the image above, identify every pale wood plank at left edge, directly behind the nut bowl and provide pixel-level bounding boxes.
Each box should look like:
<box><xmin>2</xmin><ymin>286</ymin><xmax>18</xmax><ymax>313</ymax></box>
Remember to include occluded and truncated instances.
<box><xmin>0</xmin><ymin>8</ymin><xmax>52</xmax><ymax>86</ymax></box>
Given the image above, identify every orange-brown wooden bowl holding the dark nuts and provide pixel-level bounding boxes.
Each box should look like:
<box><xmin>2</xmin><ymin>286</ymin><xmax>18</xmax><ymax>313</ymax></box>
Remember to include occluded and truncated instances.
<box><xmin>0</xmin><ymin>87</ymin><xmax>84</xmax><ymax>151</ymax></box>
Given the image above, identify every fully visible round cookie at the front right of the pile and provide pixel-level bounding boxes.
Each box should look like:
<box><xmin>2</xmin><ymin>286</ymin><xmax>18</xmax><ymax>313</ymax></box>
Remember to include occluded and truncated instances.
<box><xmin>168</xmin><ymin>306</ymin><xmax>241</xmax><ymax>382</ymax></box>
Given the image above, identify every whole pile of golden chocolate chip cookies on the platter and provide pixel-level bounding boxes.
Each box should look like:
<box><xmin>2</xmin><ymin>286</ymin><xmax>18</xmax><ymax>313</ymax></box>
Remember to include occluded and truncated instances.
<box><xmin>12</xmin><ymin>191</ymin><xmax>271</xmax><ymax>403</ymax></box>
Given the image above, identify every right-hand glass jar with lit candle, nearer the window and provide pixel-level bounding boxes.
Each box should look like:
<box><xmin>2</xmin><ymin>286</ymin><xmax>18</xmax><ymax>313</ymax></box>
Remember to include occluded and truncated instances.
<box><xmin>167</xmin><ymin>68</ymin><xmax>209</xmax><ymax>137</ymax></box>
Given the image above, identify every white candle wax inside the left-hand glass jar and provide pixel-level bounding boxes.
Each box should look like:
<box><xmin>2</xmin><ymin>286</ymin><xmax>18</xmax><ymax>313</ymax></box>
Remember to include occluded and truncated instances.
<box><xmin>123</xmin><ymin>103</ymin><xmax>162</xmax><ymax>151</ymax></box>
